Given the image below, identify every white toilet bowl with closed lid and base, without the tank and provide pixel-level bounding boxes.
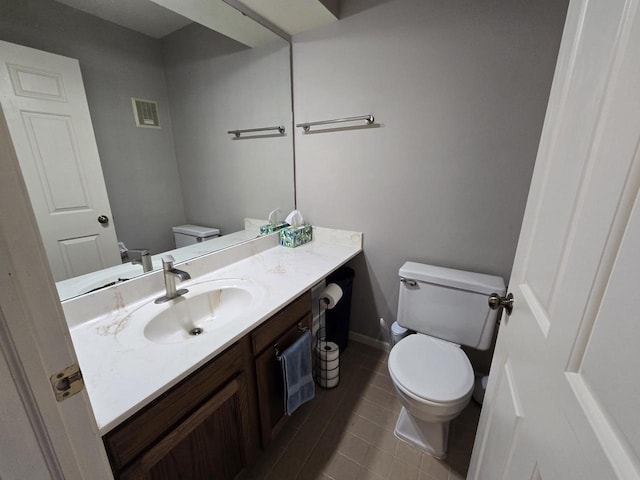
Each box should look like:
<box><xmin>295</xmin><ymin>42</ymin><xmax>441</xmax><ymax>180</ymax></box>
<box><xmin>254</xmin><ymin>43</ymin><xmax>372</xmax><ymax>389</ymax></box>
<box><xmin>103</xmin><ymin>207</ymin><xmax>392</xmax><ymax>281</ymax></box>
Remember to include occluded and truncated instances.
<box><xmin>388</xmin><ymin>333</ymin><xmax>474</xmax><ymax>458</ymax></box>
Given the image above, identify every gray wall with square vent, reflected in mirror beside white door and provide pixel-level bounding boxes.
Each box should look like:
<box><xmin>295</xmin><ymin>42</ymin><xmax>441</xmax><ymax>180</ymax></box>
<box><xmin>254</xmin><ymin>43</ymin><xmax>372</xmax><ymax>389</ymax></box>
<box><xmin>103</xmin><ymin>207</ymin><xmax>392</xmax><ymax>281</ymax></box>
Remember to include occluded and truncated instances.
<box><xmin>0</xmin><ymin>0</ymin><xmax>185</xmax><ymax>253</ymax></box>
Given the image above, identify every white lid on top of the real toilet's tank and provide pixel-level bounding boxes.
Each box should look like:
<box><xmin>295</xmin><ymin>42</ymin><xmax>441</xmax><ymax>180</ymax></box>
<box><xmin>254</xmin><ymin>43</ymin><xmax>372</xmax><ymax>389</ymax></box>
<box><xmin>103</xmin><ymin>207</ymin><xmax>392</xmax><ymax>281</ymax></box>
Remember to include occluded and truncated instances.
<box><xmin>399</xmin><ymin>262</ymin><xmax>505</xmax><ymax>295</ymax></box>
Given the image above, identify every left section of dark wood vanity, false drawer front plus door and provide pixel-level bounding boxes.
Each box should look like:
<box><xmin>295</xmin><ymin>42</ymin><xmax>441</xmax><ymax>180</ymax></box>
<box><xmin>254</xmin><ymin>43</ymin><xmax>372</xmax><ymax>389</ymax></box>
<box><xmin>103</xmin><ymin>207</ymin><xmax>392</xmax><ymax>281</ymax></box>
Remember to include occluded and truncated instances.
<box><xmin>104</xmin><ymin>337</ymin><xmax>259</xmax><ymax>480</ymax></box>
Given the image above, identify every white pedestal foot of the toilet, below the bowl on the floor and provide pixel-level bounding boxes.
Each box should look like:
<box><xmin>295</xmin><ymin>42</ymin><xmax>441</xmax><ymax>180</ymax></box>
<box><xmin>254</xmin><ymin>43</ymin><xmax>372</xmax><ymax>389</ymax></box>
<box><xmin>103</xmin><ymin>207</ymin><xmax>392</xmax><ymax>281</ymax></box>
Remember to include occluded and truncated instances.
<box><xmin>394</xmin><ymin>407</ymin><xmax>450</xmax><ymax>459</ymax></box>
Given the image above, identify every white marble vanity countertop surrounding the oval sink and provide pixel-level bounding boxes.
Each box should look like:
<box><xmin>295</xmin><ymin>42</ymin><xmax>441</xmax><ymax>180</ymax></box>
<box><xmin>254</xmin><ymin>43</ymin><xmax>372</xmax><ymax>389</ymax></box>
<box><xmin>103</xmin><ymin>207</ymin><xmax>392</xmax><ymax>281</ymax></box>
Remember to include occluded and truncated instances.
<box><xmin>68</xmin><ymin>227</ymin><xmax>362</xmax><ymax>434</ymax></box>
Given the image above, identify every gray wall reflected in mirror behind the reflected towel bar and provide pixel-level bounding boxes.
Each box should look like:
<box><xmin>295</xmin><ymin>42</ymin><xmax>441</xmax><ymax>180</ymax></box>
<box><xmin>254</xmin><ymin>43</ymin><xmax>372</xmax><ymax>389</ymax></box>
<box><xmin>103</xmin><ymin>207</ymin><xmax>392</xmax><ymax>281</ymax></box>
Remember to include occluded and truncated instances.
<box><xmin>163</xmin><ymin>24</ymin><xmax>294</xmax><ymax>233</ymax></box>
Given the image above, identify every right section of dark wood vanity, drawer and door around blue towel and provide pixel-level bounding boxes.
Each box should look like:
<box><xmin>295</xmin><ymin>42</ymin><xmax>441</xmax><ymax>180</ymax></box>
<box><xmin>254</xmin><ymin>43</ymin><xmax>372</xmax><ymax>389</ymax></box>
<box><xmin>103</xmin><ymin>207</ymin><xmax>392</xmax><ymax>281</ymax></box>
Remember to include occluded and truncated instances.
<box><xmin>251</xmin><ymin>292</ymin><xmax>313</xmax><ymax>447</ymax></box>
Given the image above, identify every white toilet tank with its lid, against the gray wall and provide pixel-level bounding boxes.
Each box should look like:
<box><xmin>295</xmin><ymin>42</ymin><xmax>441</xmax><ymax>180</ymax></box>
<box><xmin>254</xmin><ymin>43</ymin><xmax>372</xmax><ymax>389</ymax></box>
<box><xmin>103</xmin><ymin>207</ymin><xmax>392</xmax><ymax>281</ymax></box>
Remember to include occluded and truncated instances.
<box><xmin>398</xmin><ymin>262</ymin><xmax>505</xmax><ymax>350</ymax></box>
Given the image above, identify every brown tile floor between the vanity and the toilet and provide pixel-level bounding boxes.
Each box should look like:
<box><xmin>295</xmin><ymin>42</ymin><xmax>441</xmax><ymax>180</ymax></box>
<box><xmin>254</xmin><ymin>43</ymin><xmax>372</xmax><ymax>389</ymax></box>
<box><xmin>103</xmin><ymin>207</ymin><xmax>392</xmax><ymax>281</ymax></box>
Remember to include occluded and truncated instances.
<box><xmin>245</xmin><ymin>341</ymin><xmax>480</xmax><ymax>480</ymax></box>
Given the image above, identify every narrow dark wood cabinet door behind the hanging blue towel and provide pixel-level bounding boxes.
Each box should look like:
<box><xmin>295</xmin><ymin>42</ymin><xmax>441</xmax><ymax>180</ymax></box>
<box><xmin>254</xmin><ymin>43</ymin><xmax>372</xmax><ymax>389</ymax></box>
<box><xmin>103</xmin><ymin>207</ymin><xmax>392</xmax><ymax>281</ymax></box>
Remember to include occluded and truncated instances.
<box><xmin>256</xmin><ymin>313</ymin><xmax>312</xmax><ymax>447</ymax></box>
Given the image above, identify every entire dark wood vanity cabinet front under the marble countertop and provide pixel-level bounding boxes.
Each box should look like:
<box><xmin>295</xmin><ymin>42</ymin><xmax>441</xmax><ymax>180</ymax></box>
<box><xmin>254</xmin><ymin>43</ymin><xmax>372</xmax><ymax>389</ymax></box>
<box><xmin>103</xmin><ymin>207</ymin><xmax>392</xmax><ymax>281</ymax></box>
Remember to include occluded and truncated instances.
<box><xmin>103</xmin><ymin>292</ymin><xmax>312</xmax><ymax>480</ymax></box>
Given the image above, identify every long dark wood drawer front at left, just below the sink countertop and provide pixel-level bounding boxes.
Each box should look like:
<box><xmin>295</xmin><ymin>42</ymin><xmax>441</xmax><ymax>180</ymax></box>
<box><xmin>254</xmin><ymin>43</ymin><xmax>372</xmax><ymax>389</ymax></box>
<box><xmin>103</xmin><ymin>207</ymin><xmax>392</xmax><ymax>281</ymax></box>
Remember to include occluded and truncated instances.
<box><xmin>104</xmin><ymin>343</ymin><xmax>243</xmax><ymax>472</ymax></box>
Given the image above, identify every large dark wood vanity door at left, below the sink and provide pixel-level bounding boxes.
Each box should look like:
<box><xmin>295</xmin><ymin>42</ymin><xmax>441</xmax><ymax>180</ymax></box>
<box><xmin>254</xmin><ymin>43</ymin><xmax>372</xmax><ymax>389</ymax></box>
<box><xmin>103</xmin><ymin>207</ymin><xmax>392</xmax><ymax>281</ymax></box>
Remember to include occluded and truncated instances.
<box><xmin>120</xmin><ymin>374</ymin><xmax>255</xmax><ymax>480</ymax></box>
